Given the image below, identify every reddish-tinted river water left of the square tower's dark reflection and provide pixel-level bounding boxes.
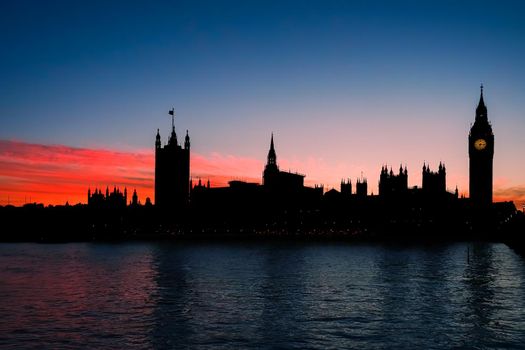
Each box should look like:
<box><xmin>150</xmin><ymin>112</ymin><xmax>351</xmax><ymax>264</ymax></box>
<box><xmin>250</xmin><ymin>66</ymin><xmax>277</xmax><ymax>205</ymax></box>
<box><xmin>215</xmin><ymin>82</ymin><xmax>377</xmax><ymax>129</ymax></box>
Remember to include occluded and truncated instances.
<box><xmin>0</xmin><ymin>244</ymin><xmax>155</xmax><ymax>348</ymax></box>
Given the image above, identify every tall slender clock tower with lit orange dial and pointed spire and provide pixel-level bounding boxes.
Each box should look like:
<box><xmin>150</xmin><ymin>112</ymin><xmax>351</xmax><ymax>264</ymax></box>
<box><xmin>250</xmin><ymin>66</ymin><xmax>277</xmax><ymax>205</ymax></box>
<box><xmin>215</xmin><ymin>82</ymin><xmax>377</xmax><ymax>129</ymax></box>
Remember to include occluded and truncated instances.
<box><xmin>468</xmin><ymin>85</ymin><xmax>494</xmax><ymax>205</ymax></box>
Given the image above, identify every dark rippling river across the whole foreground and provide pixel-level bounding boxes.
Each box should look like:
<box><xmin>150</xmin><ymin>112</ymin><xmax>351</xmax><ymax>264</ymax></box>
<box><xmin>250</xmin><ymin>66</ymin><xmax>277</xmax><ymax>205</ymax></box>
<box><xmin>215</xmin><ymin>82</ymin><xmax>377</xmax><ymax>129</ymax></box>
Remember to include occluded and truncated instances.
<box><xmin>0</xmin><ymin>242</ymin><xmax>525</xmax><ymax>349</ymax></box>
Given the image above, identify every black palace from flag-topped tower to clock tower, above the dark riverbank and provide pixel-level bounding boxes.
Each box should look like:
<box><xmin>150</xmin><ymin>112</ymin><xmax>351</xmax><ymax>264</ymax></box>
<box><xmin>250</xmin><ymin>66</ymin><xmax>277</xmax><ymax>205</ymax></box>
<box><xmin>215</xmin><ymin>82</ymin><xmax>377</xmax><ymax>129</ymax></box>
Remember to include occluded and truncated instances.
<box><xmin>151</xmin><ymin>85</ymin><xmax>494</xmax><ymax>210</ymax></box>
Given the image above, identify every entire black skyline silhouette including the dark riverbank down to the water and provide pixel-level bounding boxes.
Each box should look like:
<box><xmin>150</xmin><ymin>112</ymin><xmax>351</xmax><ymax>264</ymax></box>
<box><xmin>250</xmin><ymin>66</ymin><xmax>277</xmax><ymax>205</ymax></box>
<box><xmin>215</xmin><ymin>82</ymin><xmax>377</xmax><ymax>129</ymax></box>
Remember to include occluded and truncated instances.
<box><xmin>0</xmin><ymin>87</ymin><xmax>525</xmax><ymax>243</ymax></box>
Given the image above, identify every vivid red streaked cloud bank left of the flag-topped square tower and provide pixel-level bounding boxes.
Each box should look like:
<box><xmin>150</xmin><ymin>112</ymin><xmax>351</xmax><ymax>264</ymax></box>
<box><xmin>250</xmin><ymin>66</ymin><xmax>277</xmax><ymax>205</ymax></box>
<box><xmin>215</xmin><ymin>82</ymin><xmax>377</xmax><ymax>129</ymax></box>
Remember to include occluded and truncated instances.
<box><xmin>0</xmin><ymin>140</ymin><xmax>154</xmax><ymax>205</ymax></box>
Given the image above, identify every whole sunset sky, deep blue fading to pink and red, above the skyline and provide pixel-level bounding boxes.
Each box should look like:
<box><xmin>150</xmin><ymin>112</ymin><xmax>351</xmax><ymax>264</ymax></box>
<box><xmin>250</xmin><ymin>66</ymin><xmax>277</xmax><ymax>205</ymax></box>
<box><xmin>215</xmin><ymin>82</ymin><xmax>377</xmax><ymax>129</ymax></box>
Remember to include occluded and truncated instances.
<box><xmin>0</xmin><ymin>0</ymin><xmax>525</xmax><ymax>206</ymax></box>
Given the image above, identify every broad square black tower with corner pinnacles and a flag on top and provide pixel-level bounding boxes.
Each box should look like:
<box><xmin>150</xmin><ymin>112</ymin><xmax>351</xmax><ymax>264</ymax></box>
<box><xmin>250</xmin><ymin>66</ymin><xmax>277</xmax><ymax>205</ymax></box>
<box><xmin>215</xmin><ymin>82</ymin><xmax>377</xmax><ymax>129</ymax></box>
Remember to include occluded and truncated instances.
<box><xmin>155</xmin><ymin>109</ymin><xmax>190</xmax><ymax>209</ymax></box>
